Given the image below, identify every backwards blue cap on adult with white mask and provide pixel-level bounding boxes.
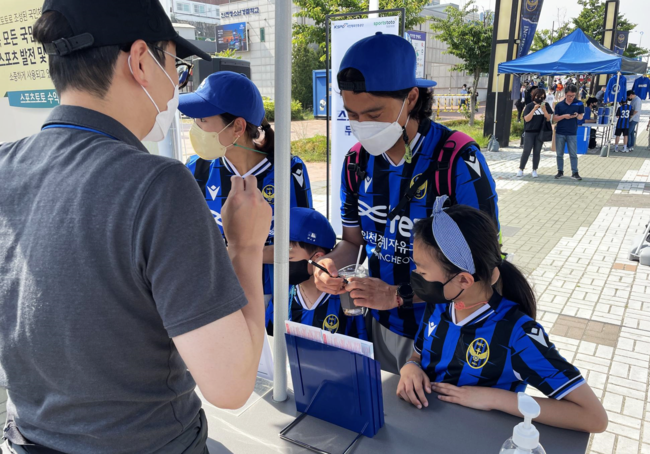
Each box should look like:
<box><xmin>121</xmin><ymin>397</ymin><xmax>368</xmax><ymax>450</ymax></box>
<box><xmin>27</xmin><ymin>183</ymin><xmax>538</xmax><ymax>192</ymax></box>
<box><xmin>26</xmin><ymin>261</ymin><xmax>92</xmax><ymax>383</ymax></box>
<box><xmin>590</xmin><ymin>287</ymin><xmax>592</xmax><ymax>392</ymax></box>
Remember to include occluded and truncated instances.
<box><xmin>339</xmin><ymin>32</ymin><xmax>436</xmax><ymax>92</ymax></box>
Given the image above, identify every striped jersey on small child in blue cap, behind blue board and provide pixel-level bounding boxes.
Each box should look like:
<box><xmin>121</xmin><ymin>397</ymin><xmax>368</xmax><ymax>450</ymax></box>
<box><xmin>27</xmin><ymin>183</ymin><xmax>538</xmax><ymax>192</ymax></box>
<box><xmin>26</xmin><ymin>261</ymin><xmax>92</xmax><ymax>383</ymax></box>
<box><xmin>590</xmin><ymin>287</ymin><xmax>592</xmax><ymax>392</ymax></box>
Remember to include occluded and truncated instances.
<box><xmin>265</xmin><ymin>285</ymin><xmax>368</xmax><ymax>340</ymax></box>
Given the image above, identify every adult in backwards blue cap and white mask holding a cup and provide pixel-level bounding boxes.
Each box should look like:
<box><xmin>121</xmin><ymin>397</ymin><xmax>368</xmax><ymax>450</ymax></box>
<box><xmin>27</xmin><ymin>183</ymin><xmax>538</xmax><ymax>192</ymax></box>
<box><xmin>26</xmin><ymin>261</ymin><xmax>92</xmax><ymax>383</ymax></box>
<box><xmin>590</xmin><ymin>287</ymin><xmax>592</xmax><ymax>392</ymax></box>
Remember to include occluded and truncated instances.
<box><xmin>316</xmin><ymin>33</ymin><xmax>498</xmax><ymax>373</ymax></box>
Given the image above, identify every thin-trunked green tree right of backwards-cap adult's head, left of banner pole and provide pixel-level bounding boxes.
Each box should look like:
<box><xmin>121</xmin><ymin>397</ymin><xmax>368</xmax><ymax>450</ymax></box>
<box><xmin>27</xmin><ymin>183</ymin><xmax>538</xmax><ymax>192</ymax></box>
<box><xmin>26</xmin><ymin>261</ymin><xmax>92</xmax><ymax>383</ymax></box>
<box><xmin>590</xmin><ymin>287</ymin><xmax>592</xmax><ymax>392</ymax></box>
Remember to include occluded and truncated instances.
<box><xmin>431</xmin><ymin>0</ymin><xmax>492</xmax><ymax>126</ymax></box>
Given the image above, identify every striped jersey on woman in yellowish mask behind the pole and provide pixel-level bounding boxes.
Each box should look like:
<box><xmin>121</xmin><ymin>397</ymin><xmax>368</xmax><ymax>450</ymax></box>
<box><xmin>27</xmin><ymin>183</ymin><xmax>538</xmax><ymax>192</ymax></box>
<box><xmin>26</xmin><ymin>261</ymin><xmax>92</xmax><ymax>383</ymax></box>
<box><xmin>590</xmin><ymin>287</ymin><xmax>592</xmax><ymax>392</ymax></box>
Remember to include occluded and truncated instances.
<box><xmin>186</xmin><ymin>156</ymin><xmax>313</xmax><ymax>295</ymax></box>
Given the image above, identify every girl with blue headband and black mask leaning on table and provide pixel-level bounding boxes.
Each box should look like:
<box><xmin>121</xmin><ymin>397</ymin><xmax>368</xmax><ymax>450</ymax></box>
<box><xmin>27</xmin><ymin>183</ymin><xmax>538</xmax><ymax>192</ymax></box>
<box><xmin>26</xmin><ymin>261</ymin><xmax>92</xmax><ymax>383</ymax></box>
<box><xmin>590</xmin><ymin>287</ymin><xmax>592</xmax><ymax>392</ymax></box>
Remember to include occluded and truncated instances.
<box><xmin>396</xmin><ymin>197</ymin><xmax>607</xmax><ymax>432</ymax></box>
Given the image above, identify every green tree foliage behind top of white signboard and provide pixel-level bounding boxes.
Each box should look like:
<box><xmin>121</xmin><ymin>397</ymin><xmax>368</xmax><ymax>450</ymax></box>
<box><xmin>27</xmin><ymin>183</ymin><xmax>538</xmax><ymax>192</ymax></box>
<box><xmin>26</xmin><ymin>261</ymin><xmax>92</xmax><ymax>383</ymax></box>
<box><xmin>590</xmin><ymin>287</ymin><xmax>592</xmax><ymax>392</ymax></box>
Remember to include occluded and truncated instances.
<box><xmin>293</xmin><ymin>0</ymin><xmax>430</xmax><ymax>61</ymax></box>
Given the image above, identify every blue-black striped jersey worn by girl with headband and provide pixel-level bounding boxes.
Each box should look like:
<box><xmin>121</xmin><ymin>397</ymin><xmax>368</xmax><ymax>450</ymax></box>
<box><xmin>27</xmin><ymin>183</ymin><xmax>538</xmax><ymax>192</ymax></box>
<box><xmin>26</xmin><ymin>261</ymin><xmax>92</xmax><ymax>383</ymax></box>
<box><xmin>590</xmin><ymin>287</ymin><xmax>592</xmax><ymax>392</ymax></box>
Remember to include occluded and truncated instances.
<box><xmin>413</xmin><ymin>293</ymin><xmax>585</xmax><ymax>399</ymax></box>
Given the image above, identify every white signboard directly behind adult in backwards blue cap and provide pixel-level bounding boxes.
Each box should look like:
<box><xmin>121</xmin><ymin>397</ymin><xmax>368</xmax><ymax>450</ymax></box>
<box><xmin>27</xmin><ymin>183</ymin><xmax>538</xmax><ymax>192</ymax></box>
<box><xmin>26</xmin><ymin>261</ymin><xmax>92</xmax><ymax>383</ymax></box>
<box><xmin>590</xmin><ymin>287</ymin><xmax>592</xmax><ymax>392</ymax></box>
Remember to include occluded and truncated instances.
<box><xmin>330</xmin><ymin>17</ymin><xmax>400</xmax><ymax>235</ymax></box>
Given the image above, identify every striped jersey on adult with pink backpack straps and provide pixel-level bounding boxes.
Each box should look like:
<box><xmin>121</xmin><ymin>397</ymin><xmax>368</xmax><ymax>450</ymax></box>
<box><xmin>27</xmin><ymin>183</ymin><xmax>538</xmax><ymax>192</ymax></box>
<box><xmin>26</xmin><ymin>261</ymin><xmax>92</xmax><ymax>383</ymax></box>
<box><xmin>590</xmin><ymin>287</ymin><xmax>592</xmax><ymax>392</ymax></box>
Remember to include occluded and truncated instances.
<box><xmin>341</xmin><ymin>119</ymin><xmax>498</xmax><ymax>339</ymax></box>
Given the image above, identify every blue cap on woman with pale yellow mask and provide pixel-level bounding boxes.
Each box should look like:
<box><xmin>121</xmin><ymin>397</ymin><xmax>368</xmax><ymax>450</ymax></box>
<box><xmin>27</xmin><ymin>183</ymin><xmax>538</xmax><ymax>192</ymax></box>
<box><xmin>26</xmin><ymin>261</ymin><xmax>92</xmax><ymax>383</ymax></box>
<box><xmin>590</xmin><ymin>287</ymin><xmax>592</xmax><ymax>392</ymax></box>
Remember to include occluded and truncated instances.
<box><xmin>178</xmin><ymin>71</ymin><xmax>264</xmax><ymax>126</ymax></box>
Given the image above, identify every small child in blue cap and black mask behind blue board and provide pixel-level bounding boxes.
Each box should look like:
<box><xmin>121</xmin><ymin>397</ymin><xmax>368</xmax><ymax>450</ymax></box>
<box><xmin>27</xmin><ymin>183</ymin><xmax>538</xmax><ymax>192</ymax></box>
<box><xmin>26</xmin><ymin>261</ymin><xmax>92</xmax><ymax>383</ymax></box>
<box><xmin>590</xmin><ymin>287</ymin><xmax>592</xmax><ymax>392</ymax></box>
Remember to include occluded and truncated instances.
<box><xmin>266</xmin><ymin>208</ymin><xmax>368</xmax><ymax>340</ymax></box>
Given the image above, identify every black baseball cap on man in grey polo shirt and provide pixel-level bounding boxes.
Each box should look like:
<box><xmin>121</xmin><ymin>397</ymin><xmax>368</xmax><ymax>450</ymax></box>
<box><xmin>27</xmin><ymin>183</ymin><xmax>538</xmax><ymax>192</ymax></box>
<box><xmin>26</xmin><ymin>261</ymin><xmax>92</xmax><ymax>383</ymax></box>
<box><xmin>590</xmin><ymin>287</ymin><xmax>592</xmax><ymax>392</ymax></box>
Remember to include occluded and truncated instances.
<box><xmin>42</xmin><ymin>0</ymin><xmax>211</xmax><ymax>61</ymax></box>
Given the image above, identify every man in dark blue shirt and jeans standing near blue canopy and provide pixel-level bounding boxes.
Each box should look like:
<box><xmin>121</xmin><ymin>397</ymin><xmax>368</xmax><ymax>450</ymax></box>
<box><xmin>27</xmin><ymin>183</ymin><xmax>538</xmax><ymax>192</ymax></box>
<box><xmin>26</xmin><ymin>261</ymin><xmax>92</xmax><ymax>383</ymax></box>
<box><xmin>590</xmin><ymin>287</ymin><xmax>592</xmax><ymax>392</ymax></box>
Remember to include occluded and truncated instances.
<box><xmin>553</xmin><ymin>84</ymin><xmax>585</xmax><ymax>180</ymax></box>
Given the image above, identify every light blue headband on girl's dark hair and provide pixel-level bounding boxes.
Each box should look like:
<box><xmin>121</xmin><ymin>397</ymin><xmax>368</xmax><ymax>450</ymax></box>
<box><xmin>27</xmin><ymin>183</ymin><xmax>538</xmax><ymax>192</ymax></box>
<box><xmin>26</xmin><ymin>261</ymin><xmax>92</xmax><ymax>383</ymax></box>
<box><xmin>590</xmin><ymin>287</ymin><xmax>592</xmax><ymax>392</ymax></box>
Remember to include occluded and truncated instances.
<box><xmin>432</xmin><ymin>195</ymin><xmax>476</xmax><ymax>275</ymax></box>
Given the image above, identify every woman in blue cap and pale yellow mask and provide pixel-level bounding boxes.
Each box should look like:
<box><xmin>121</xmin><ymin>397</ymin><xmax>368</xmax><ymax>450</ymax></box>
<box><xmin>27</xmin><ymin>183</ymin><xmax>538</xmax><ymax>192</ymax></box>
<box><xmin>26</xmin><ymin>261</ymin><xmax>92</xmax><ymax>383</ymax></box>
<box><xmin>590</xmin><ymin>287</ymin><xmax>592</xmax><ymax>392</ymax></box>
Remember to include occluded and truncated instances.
<box><xmin>178</xmin><ymin>71</ymin><xmax>312</xmax><ymax>302</ymax></box>
